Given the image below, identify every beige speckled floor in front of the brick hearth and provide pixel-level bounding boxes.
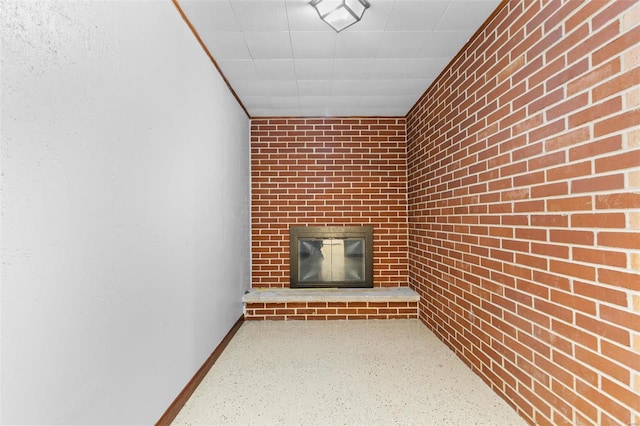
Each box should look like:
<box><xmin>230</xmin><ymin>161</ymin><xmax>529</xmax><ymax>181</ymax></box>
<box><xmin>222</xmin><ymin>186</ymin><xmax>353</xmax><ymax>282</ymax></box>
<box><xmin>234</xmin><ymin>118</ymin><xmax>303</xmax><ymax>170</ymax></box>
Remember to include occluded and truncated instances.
<box><xmin>173</xmin><ymin>320</ymin><xmax>526</xmax><ymax>425</ymax></box>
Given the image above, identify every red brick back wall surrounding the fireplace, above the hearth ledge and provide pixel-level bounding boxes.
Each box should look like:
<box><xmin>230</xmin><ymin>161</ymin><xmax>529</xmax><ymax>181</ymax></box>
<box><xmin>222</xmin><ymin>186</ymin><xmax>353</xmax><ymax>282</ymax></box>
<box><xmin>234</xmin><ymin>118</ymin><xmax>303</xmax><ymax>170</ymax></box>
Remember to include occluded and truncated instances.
<box><xmin>251</xmin><ymin>118</ymin><xmax>408</xmax><ymax>287</ymax></box>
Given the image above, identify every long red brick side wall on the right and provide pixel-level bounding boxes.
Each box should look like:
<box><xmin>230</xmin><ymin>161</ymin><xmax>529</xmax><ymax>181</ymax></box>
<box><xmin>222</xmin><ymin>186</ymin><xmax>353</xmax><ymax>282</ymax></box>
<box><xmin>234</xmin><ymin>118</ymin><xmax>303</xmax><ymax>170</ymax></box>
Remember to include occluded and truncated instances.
<box><xmin>407</xmin><ymin>0</ymin><xmax>640</xmax><ymax>424</ymax></box>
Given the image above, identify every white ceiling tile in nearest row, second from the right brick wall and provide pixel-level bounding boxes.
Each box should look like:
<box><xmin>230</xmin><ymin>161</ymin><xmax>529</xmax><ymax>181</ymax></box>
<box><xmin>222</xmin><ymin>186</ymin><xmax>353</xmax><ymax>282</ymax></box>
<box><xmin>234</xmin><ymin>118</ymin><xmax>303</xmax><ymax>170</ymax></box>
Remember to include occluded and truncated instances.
<box><xmin>386</xmin><ymin>0</ymin><xmax>448</xmax><ymax>31</ymax></box>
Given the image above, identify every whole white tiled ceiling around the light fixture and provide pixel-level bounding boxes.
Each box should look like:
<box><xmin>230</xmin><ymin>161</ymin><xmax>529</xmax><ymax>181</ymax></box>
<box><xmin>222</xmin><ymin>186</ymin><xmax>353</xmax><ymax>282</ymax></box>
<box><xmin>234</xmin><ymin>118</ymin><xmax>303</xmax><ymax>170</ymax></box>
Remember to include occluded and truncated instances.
<box><xmin>178</xmin><ymin>0</ymin><xmax>500</xmax><ymax>117</ymax></box>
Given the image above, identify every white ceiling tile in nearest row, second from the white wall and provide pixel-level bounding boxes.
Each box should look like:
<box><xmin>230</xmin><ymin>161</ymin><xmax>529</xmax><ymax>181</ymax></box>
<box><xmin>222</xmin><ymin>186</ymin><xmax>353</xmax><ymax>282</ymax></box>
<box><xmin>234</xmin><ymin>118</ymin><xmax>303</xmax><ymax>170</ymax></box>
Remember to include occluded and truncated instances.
<box><xmin>230</xmin><ymin>0</ymin><xmax>289</xmax><ymax>31</ymax></box>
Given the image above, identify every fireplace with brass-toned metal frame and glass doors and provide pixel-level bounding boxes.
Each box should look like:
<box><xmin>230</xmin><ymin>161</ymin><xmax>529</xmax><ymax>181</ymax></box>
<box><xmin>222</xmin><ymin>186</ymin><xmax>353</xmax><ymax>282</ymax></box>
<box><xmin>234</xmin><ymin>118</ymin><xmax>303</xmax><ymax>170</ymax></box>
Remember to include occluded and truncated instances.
<box><xmin>289</xmin><ymin>226</ymin><xmax>373</xmax><ymax>288</ymax></box>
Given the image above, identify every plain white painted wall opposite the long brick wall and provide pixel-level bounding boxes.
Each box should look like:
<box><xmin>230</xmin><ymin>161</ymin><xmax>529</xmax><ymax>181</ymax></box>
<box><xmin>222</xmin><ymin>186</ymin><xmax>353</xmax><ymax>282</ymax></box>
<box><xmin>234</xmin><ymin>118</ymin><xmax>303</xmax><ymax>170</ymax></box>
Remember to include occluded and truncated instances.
<box><xmin>0</xmin><ymin>0</ymin><xmax>250</xmax><ymax>424</ymax></box>
